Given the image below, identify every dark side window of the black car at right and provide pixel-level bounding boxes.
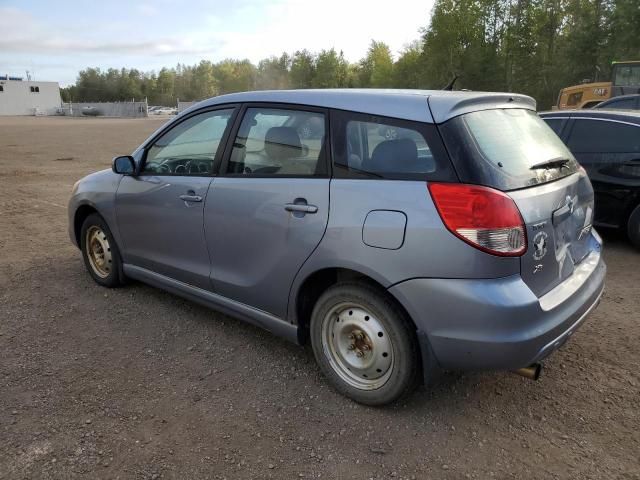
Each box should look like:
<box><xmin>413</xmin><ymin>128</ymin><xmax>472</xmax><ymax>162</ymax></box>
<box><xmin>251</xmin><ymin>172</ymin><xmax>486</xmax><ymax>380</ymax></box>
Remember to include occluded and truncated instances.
<box><xmin>567</xmin><ymin>118</ymin><xmax>640</xmax><ymax>153</ymax></box>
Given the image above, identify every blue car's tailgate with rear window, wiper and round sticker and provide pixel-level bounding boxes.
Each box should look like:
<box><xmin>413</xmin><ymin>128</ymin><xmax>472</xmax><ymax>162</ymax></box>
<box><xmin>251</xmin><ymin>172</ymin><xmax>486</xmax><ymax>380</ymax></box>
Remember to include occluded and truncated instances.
<box><xmin>441</xmin><ymin>109</ymin><xmax>595</xmax><ymax>296</ymax></box>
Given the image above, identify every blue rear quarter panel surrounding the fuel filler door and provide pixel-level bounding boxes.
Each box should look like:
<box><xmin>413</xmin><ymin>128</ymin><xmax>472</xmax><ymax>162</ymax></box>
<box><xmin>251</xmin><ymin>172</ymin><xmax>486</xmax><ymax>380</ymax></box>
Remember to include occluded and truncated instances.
<box><xmin>288</xmin><ymin>179</ymin><xmax>520</xmax><ymax>318</ymax></box>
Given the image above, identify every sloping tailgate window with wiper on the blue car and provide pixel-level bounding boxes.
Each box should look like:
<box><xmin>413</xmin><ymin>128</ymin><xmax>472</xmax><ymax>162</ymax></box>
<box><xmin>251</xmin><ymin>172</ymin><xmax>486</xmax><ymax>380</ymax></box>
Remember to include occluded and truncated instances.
<box><xmin>442</xmin><ymin>109</ymin><xmax>578</xmax><ymax>190</ymax></box>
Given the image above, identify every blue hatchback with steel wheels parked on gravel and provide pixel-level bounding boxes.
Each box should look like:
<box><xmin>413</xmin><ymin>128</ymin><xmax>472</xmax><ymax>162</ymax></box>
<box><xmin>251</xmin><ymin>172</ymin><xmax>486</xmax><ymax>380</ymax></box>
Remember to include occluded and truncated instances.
<box><xmin>69</xmin><ymin>90</ymin><xmax>606</xmax><ymax>405</ymax></box>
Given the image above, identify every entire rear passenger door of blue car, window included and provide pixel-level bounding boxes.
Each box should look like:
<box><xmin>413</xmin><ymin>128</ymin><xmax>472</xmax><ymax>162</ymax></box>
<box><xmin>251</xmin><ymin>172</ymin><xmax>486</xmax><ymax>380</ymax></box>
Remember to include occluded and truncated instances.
<box><xmin>204</xmin><ymin>105</ymin><xmax>330</xmax><ymax>318</ymax></box>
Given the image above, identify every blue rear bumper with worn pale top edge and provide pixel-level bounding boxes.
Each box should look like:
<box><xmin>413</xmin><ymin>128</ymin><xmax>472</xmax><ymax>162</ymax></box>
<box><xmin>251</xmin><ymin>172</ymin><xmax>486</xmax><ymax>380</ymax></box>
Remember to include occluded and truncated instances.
<box><xmin>389</xmin><ymin>251</ymin><xmax>606</xmax><ymax>370</ymax></box>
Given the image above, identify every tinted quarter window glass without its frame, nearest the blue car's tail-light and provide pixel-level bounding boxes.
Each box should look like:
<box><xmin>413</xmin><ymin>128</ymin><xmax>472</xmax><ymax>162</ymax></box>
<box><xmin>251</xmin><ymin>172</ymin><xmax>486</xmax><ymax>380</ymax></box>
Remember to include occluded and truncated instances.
<box><xmin>338</xmin><ymin>119</ymin><xmax>436</xmax><ymax>176</ymax></box>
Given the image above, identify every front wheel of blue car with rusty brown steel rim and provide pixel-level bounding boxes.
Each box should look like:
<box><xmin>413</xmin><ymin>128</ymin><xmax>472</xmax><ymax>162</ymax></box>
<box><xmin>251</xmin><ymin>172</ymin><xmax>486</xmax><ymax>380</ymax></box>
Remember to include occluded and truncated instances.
<box><xmin>80</xmin><ymin>213</ymin><xmax>122</xmax><ymax>288</ymax></box>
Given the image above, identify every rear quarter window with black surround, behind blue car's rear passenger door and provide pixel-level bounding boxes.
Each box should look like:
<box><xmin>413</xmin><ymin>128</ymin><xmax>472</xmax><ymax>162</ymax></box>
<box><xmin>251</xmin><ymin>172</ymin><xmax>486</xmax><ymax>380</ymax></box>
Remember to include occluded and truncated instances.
<box><xmin>332</xmin><ymin>111</ymin><xmax>453</xmax><ymax>180</ymax></box>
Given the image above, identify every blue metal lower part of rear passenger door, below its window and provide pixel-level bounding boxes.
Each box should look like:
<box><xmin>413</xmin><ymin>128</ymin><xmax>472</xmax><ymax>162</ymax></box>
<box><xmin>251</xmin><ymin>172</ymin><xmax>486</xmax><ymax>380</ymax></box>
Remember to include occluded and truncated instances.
<box><xmin>204</xmin><ymin>176</ymin><xmax>330</xmax><ymax>318</ymax></box>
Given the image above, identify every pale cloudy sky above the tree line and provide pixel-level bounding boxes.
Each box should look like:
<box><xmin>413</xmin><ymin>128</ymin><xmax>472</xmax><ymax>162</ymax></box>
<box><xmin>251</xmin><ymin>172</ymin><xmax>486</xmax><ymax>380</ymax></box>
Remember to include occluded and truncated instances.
<box><xmin>0</xmin><ymin>0</ymin><xmax>433</xmax><ymax>86</ymax></box>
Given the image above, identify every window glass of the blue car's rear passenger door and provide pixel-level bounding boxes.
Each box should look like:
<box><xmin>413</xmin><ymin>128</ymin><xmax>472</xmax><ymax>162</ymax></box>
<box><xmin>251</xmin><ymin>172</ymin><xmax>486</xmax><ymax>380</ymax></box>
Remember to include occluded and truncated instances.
<box><xmin>227</xmin><ymin>108</ymin><xmax>326</xmax><ymax>176</ymax></box>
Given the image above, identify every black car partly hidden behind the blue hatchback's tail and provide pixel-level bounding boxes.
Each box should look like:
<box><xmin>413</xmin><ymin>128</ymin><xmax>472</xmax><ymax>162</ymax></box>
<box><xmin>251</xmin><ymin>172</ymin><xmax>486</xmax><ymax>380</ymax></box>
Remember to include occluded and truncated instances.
<box><xmin>540</xmin><ymin>110</ymin><xmax>640</xmax><ymax>248</ymax></box>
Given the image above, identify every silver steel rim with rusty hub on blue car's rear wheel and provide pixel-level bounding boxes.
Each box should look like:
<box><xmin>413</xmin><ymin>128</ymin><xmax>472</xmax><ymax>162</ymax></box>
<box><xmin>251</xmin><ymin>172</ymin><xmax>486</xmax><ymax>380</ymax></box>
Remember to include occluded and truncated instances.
<box><xmin>322</xmin><ymin>303</ymin><xmax>394</xmax><ymax>390</ymax></box>
